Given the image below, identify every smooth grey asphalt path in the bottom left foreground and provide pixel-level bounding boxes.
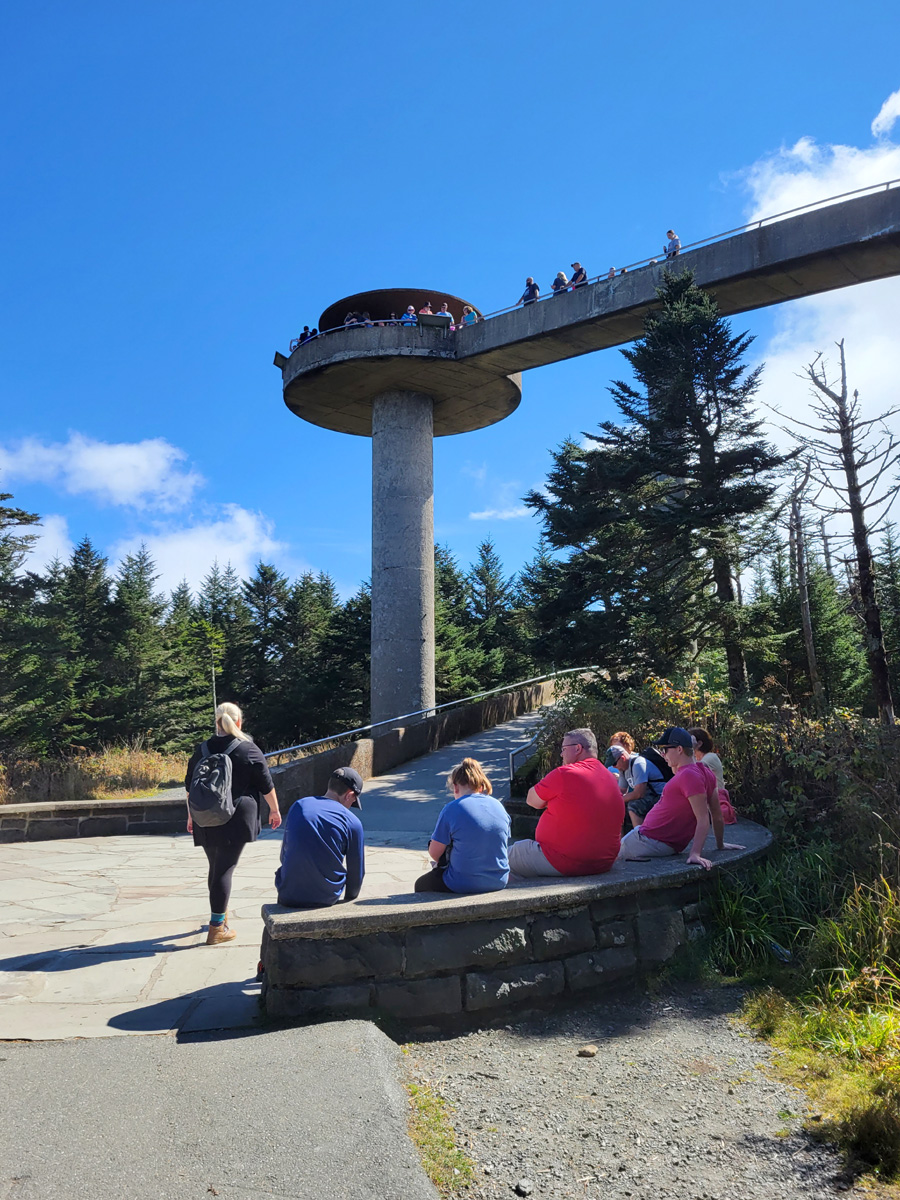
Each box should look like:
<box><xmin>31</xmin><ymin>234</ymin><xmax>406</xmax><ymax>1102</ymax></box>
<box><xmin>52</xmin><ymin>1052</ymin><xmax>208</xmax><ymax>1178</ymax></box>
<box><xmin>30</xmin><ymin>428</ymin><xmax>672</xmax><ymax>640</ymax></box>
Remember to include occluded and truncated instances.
<box><xmin>0</xmin><ymin>1021</ymin><xmax>437</xmax><ymax>1200</ymax></box>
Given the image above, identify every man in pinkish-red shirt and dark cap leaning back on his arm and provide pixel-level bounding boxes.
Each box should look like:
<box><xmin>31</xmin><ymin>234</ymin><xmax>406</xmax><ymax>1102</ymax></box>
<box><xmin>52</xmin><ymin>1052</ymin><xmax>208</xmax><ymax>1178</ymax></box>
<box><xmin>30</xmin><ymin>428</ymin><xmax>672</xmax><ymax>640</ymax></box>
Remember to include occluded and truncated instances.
<box><xmin>619</xmin><ymin>726</ymin><xmax>744</xmax><ymax>871</ymax></box>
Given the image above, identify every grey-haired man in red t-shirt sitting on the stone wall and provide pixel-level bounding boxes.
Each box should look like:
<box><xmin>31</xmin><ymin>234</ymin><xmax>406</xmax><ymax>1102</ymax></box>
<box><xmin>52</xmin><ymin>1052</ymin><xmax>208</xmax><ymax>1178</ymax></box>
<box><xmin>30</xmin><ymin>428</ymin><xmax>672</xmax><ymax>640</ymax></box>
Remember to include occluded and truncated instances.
<box><xmin>509</xmin><ymin>730</ymin><xmax>625</xmax><ymax>877</ymax></box>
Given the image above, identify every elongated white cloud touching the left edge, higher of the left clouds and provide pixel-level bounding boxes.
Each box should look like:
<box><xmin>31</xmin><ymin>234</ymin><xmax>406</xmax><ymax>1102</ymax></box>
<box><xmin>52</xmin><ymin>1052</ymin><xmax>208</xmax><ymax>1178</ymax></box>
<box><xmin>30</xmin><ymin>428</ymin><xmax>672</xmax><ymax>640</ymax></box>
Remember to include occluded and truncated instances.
<box><xmin>0</xmin><ymin>433</ymin><xmax>203</xmax><ymax>511</ymax></box>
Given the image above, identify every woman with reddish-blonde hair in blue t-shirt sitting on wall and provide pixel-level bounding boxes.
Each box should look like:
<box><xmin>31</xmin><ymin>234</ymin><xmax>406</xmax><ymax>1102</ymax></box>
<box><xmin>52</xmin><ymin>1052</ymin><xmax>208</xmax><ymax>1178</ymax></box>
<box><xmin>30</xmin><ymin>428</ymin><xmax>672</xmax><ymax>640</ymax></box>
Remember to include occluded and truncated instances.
<box><xmin>415</xmin><ymin>758</ymin><xmax>509</xmax><ymax>894</ymax></box>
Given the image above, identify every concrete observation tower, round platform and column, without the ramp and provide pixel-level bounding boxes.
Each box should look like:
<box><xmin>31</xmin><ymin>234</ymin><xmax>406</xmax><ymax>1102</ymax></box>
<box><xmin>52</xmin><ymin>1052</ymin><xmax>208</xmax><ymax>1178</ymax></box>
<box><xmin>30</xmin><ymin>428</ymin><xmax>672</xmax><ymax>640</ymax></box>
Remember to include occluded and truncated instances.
<box><xmin>275</xmin><ymin>288</ymin><xmax>522</xmax><ymax>722</ymax></box>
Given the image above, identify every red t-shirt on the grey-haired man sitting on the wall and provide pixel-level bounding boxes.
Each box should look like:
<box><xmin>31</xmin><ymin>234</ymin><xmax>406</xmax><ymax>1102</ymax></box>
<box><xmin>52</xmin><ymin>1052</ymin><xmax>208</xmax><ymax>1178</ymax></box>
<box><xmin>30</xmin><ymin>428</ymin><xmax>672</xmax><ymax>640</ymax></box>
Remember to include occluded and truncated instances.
<box><xmin>534</xmin><ymin>758</ymin><xmax>625</xmax><ymax>875</ymax></box>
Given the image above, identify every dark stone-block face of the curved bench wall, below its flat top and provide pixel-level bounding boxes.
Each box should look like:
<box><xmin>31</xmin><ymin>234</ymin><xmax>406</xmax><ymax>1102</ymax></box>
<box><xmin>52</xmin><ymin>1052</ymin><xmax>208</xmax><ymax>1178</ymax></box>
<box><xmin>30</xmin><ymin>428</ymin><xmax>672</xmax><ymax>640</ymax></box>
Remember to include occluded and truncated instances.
<box><xmin>263</xmin><ymin>880</ymin><xmax>703</xmax><ymax>1024</ymax></box>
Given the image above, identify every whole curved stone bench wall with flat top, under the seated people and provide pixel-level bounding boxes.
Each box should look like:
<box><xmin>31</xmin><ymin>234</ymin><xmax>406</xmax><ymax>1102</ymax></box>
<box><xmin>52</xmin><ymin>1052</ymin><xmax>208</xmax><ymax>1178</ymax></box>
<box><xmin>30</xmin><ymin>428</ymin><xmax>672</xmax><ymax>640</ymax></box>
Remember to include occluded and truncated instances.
<box><xmin>262</xmin><ymin>821</ymin><xmax>772</xmax><ymax>1025</ymax></box>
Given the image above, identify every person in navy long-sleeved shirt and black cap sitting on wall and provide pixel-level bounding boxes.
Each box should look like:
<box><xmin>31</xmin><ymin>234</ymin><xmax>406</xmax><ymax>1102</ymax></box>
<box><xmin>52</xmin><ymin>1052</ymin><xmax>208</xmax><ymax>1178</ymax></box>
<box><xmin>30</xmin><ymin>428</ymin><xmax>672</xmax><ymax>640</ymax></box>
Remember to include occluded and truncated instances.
<box><xmin>275</xmin><ymin>767</ymin><xmax>365</xmax><ymax>908</ymax></box>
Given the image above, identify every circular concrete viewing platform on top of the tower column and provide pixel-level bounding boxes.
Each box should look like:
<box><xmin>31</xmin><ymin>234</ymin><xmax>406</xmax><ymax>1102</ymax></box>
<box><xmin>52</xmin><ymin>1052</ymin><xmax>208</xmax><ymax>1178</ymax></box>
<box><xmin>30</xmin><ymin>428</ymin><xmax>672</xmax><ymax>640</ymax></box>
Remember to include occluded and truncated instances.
<box><xmin>275</xmin><ymin>288</ymin><xmax>522</xmax><ymax>437</ymax></box>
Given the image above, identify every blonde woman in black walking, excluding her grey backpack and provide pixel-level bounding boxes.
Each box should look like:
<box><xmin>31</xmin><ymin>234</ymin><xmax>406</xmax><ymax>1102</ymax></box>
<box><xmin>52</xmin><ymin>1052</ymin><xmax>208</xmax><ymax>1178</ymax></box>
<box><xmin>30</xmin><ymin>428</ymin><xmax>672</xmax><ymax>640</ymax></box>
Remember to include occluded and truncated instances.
<box><xmin>185</xmin><ymin>703</ymin><xmax>281</xmax><ymax>946</ymax></box>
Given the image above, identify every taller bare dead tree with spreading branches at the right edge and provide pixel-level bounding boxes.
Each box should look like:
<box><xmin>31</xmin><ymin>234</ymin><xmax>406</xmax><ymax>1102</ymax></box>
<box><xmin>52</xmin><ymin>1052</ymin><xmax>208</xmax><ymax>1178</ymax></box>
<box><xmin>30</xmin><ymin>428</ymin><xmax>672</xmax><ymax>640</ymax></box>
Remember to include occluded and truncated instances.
<box><xmin>788</xmin><ymin>338</ymin><xmax>900</xmax><ymax>725</ymax></box>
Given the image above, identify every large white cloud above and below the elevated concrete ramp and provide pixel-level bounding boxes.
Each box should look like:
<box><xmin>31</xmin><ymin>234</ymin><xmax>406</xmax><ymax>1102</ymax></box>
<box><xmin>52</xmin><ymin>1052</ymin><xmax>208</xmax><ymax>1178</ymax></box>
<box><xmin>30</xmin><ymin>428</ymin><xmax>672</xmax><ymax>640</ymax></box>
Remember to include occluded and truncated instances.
<box><xmin>745</xmin><ymin>92</ymin><xmax>900</xmax><ymax>530</ymax></box>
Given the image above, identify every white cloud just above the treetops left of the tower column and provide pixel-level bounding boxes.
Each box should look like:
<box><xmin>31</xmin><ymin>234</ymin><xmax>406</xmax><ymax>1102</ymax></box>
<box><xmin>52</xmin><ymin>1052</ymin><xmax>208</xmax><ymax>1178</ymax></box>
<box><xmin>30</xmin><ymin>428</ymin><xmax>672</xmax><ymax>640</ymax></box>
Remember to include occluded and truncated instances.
<box><xmin>110</xmin><ymin>504</ymin><xmax>294</xmax><ymax>590</ymax></box>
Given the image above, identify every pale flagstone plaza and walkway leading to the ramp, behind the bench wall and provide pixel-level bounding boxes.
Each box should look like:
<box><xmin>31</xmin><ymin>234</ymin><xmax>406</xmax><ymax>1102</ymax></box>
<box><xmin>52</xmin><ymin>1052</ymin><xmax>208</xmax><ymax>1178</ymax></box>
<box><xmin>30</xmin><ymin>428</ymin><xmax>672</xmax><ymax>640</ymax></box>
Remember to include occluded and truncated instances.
<box><xmin>0</xmin><ymin>714</ymin><xmax>539</xmax><ymax>1040</ymax></box>
